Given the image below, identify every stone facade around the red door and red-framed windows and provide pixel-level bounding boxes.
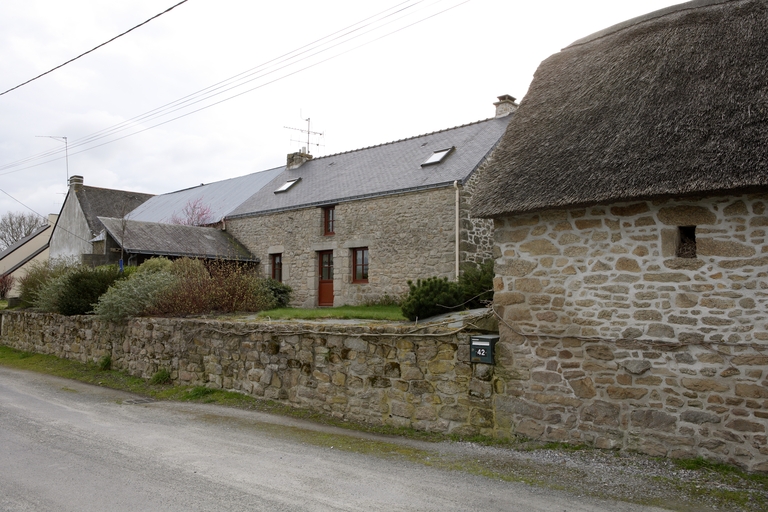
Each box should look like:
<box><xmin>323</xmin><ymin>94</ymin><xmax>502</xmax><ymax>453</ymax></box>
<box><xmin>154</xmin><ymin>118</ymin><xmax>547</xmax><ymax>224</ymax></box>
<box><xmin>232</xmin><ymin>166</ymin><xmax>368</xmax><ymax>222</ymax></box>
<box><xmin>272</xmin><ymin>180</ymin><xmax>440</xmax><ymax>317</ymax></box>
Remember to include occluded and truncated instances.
<box><xmin>227</xmin><ymin>185</ymin><xmax>492</xmax><ymax>307</ymax></box>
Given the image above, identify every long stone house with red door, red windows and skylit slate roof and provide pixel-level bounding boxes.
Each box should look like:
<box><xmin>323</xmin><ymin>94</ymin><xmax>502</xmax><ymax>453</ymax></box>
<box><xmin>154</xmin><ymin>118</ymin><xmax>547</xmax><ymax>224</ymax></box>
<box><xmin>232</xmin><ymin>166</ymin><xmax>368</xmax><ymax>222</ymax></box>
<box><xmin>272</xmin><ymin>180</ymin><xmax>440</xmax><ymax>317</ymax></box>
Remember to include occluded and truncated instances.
<box><xmin>224</xmin><ymin>95</ymin><xmax>517</xmax><ymax>307</ymax></box>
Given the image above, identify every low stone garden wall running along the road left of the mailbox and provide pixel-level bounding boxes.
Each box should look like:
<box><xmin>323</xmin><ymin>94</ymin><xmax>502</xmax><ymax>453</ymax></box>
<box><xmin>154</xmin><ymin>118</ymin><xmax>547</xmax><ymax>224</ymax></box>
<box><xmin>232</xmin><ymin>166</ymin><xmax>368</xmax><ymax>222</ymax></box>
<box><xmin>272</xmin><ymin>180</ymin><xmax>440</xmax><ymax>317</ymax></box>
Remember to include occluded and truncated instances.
<box><xmin>0</xmin><ymin>311</ymin><xmax>494</xmax><ymax>435</ymax></box>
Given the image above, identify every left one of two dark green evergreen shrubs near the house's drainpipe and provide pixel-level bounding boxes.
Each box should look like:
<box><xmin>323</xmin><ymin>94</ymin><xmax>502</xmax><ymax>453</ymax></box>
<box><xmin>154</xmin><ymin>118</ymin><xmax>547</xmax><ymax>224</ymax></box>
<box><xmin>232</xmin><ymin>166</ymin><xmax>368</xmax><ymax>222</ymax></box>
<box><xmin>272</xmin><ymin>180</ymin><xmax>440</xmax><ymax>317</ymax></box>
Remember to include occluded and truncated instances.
<box><xmin>400</xmin><ymin>277</ymin><xmax>462</xmax><ymax>320</ymax></box>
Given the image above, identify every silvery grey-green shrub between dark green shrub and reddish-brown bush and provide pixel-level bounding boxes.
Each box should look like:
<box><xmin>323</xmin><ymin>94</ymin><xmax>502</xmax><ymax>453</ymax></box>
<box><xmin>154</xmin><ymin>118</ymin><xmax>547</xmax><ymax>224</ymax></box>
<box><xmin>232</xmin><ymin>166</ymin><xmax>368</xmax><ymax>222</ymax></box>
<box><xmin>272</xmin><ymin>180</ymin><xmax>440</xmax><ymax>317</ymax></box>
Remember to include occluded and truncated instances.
<box><xmin>93</xmin><ymin>268</ymin><xmax>177</xmax><ymax>322</ymax></box>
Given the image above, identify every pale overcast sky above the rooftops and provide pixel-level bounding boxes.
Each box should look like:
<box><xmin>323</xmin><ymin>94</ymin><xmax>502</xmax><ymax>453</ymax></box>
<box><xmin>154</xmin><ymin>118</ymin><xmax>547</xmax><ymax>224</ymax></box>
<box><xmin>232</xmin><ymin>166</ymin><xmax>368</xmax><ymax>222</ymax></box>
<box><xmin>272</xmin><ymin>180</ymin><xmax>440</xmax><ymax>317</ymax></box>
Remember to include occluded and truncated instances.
<box><xmin>0</xmin><ymin>0</ymin><xmax>679</xmax><ymax>215</ymax></box>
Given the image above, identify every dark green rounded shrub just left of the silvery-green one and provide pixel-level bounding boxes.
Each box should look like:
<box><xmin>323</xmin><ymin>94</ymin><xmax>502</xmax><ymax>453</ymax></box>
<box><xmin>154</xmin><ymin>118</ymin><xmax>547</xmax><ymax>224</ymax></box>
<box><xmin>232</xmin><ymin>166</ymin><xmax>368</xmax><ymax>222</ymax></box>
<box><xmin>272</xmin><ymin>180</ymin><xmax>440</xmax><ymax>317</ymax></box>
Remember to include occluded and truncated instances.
<box><xmin>58</xmin><ymin>265</ymin><xmax>121</xmax><ymax>316</ymax></box>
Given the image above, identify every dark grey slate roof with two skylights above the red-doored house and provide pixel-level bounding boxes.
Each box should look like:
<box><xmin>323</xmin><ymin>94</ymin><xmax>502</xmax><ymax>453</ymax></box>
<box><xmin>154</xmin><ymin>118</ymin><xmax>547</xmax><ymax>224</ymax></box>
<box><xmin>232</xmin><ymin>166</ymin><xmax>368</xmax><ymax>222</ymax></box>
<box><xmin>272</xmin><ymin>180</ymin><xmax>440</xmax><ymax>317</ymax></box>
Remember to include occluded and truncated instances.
<box><xmin>227</xmin><ymin>114</ymin><xmax>515</xmax><ymax>218</ymax></box>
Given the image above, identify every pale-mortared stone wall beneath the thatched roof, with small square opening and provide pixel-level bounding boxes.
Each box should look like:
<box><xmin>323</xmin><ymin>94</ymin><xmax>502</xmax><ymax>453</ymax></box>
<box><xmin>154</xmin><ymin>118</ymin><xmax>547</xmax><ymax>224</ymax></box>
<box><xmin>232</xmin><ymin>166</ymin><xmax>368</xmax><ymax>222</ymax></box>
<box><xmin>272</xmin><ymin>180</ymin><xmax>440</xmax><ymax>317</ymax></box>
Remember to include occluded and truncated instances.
<box><xmin>494</xmin><ymin>195</ymin><xmax>768</xmax><ymax>471</ymax></box>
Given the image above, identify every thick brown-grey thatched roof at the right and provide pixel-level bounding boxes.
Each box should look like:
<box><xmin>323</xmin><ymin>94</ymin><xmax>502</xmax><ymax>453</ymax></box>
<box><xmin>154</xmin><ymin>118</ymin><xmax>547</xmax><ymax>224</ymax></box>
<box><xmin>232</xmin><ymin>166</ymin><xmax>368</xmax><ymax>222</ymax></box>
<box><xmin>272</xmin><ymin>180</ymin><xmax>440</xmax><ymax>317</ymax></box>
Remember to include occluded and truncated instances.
<box><xmin>473</xmin><ymin>0</ymin><xmax>768</xmax><ymax>217</ymax></box>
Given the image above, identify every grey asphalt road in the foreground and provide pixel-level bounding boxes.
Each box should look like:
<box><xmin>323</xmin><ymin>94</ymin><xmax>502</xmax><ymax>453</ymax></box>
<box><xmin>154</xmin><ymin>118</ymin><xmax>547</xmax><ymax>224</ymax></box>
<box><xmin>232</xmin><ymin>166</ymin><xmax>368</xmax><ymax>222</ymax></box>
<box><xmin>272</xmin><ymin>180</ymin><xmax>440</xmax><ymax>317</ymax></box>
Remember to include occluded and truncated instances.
<box><xmin>0</xmin><ymin>367</ymin><xmax>656</xmax><ymax>512</ymax></box>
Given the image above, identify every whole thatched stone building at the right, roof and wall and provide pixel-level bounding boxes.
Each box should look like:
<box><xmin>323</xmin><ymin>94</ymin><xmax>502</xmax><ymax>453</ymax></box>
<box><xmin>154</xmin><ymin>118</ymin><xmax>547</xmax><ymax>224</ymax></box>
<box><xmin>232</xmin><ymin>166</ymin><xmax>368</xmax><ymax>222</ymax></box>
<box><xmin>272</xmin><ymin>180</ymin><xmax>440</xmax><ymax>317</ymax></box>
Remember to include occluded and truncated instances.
<box><xmin>472</xmin><ymin>0</ymin><xmax>768</xmax><ymax>471</ymax></box>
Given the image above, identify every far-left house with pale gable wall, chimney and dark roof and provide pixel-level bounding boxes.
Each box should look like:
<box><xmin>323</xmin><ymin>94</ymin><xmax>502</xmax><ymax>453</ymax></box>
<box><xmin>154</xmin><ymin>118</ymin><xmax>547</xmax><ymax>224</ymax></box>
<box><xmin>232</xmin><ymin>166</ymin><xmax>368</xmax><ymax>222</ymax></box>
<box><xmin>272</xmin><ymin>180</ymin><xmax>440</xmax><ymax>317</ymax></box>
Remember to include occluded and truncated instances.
<box><xmin>49</xmin><ymin>176</ymin><xmax>152</xmax><ymax>264</ymax></box>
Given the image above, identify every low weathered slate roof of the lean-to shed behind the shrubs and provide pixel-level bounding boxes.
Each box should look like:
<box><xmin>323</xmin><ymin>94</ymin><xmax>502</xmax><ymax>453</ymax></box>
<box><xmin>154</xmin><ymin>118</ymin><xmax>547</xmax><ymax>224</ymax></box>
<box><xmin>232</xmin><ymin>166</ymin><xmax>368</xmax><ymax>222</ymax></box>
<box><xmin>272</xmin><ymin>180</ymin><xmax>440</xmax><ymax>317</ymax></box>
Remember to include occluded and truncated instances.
<box><xmin>99</xmin><ymin>217</ymin><xmax>259</xmax><ymax>262</ymax></box>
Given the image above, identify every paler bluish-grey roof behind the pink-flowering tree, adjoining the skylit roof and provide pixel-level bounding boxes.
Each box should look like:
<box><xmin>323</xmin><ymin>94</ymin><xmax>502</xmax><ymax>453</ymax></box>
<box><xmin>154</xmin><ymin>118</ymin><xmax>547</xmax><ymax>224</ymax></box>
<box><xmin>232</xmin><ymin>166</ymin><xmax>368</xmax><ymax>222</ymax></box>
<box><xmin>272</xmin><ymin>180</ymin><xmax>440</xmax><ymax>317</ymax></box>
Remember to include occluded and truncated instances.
<box><xmin>128</xmin><ymin>167</ymin><xmax>283</xmax><ymax>224</ymax></box>
